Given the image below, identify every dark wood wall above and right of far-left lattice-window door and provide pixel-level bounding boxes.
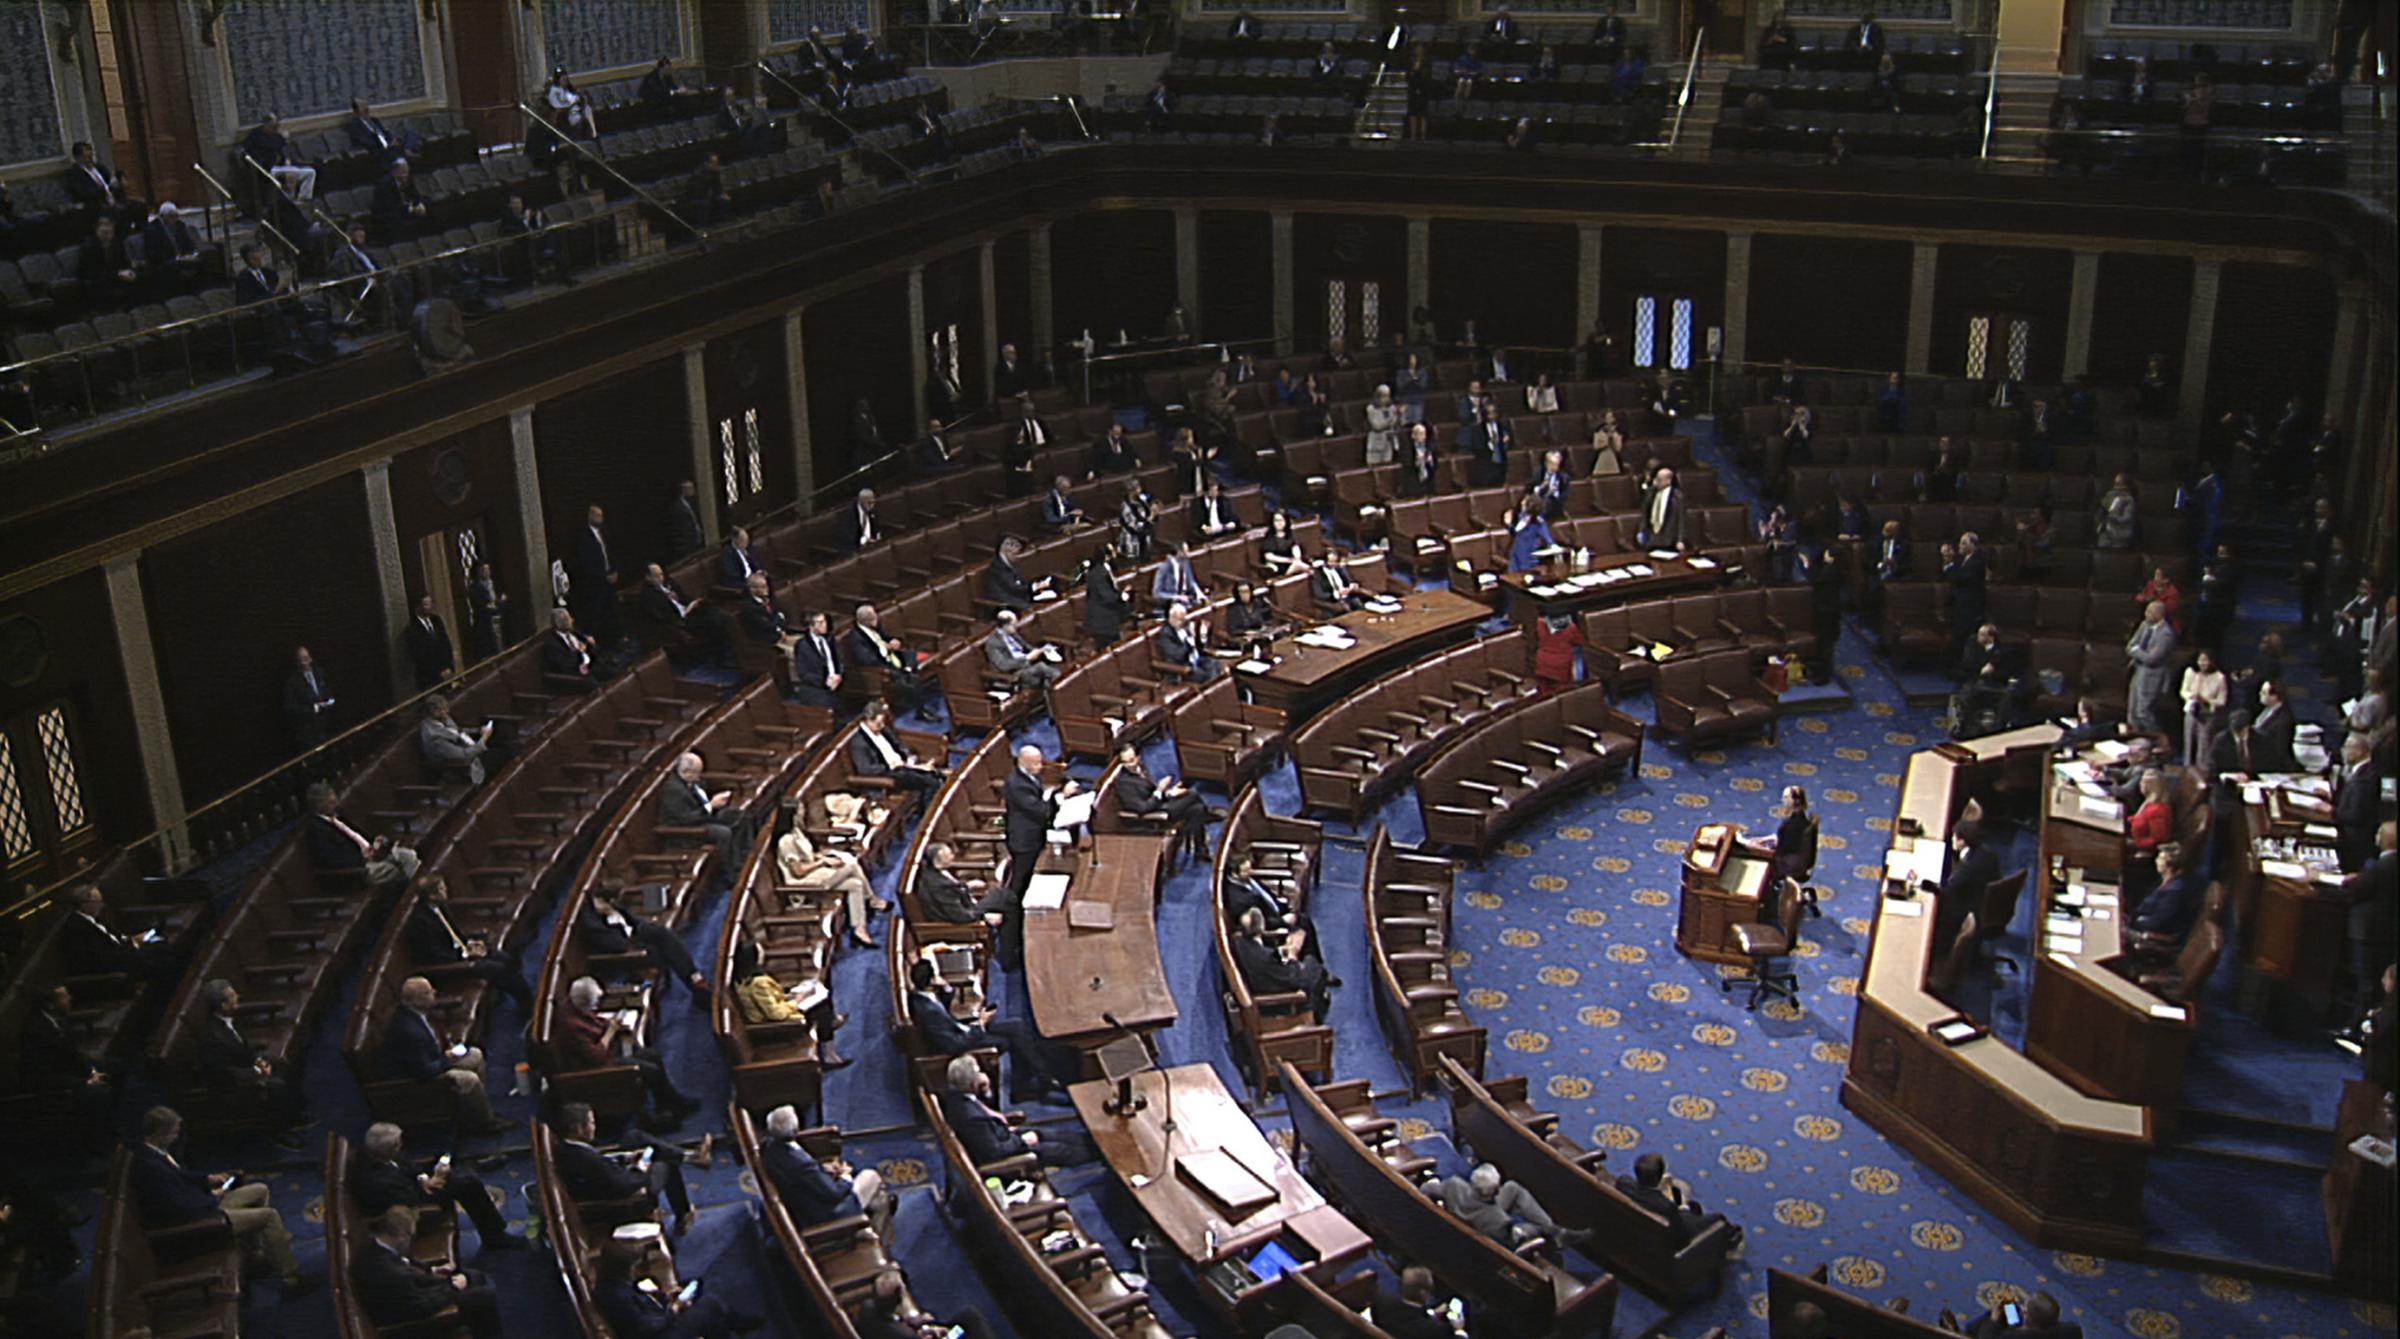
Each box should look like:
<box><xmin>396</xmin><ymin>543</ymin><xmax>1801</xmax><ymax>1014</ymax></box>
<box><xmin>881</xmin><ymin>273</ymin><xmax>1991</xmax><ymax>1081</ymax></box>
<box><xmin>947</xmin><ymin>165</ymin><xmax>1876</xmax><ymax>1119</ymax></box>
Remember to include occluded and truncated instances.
<box><xmin>0</xmin><ymin>569</ymin><xmax>148</xmax><ymax>842</ymax></box>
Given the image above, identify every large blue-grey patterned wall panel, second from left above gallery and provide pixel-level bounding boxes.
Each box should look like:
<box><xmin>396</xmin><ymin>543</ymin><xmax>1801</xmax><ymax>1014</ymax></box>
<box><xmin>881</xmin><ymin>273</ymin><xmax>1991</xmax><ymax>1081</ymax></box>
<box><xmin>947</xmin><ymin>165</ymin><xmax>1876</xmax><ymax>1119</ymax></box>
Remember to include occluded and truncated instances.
<box><xmin>216</xmin><ymin>0</ymin><xmax>425</xmax><ymax>127</ymax></box>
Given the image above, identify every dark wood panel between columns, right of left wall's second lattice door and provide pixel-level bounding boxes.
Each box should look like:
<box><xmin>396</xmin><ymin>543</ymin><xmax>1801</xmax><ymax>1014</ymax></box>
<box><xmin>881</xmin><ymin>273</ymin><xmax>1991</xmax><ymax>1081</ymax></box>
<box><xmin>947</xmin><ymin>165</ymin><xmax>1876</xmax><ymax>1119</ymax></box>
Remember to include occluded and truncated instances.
<box><xmin>802</xmin><ymin>276</ymin><xmax>917</xmax><ymax>490</ymax></box>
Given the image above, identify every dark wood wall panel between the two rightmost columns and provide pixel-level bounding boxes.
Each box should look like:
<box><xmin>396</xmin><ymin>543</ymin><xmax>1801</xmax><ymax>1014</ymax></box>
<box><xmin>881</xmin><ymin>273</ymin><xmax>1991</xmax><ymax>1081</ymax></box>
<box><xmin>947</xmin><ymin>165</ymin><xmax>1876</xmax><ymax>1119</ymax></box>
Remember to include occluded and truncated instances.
<box><xmin>2208</xmin><ymin>262</ymin><xmax>2332</xmax><ymax>425</ymax></box>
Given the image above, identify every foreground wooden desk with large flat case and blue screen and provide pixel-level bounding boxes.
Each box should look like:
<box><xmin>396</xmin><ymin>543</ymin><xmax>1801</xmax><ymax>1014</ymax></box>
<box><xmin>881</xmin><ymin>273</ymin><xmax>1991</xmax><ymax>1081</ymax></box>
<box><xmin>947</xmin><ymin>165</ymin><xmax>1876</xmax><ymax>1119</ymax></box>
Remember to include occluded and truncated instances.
<box><xmin>1068</xmin><ymin>1065</ymin><xmax>1373</xmax><ymax>1305</ymax></box>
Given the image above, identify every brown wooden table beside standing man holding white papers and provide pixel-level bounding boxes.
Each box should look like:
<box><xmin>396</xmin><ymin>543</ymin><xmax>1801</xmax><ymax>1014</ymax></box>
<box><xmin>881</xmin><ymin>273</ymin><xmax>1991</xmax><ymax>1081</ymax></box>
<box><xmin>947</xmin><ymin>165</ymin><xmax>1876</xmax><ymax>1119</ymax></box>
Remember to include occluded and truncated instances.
<box><xmin>1025</xmin><ymin>835</ymin><xmax>1176</xmax><ymax>1046</ymax></box>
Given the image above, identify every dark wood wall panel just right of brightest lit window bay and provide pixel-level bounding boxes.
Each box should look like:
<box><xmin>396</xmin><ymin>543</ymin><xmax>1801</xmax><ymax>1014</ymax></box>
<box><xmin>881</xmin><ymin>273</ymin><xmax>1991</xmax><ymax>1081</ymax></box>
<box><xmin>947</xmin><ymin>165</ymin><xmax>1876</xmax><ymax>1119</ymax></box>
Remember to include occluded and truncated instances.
<box><xmin>1750</xmin><ymin>233</ymin><xmax>1910</xmax><ymax>367</ymax></box>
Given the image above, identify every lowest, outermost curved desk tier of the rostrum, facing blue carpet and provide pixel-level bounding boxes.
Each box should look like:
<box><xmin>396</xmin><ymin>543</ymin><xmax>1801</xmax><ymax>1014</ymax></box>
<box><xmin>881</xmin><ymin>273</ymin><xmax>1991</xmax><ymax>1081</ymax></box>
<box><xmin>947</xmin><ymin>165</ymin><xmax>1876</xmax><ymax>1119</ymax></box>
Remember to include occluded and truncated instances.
<box><xmin>1841</xmin><ymin>725</ymin><xmax>2153</xmax><ymax>1253</ymax></box>
